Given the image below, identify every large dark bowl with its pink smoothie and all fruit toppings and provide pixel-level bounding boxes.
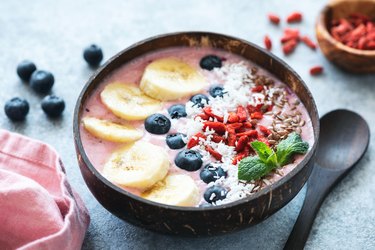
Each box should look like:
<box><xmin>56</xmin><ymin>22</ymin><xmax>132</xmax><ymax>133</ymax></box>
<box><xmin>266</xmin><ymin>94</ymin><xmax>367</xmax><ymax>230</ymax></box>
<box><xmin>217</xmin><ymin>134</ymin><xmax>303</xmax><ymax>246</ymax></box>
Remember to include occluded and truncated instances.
<box><xmin>74</xmin><ymin>32</ymin><xmax>319</xmax><ymax>235</ymax></box>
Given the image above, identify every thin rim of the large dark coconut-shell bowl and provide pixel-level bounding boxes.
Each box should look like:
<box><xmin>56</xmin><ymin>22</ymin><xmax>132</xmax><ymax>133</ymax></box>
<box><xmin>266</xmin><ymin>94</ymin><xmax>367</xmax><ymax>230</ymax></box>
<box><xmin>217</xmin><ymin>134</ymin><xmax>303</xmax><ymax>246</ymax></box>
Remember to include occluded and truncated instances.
<box><xmin>73</xmin><ymin>31</ymin><xmax>320</xmax><ymax>212</ymax></box>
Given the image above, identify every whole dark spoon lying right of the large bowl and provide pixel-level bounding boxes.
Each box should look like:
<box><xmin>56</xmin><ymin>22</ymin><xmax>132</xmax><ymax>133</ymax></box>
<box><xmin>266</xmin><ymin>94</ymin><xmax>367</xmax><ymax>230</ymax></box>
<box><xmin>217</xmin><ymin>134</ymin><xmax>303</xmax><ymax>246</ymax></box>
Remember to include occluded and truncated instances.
<box><xmin>284</xmin><ymin>110</ymin><xmax>370</xmax><ymax>250</ymax></box>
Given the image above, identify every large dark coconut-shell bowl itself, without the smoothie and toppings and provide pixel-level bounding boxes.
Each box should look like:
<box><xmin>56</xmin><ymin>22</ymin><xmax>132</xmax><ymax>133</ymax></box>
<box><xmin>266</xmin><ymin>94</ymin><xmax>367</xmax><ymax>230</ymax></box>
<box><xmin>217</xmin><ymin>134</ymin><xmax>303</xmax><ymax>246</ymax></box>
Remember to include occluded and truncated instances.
<box><xmin>73</xmin><ymin>32</ymin><xmax>319</xmax><ymax>235</ymax></box>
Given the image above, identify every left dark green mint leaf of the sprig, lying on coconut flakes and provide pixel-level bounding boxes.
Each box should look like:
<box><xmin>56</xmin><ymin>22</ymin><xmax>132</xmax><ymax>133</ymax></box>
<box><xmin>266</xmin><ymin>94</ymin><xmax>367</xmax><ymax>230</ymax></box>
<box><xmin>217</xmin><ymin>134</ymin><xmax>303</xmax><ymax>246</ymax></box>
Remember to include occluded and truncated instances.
<box><xmin>238</xmin><ymin>156</ymin><xmax>273</xmax><ymax>181</ymax></box>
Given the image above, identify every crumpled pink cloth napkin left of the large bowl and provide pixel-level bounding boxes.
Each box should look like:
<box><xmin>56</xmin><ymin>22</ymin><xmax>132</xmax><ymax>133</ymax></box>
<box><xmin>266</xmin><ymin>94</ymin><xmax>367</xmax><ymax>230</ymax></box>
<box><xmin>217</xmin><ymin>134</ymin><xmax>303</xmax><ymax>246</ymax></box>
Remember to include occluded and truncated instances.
<box><xmin>0</xmin><ymin>129</ymin><xmax>90</xmax><ymax>250</ymax></box>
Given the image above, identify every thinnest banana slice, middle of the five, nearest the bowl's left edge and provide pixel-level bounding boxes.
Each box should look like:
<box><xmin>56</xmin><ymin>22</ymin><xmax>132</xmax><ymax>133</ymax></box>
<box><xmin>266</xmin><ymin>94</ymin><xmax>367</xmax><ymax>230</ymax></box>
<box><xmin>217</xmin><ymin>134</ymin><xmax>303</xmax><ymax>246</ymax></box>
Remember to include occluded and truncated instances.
<box><xmin>82</xmin><ymin>117</ymin><xmax>143</xmax><ymax>142</ymax></box>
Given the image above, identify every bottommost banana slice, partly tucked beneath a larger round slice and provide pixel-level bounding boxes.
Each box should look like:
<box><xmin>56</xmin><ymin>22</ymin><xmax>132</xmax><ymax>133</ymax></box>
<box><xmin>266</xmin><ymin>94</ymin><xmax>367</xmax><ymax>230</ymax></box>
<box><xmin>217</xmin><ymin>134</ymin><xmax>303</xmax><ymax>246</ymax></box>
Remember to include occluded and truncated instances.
<box><xmin>141</xmin><ymin>175</ymin><xmax>200</xmax><ymax>206</ymax></box>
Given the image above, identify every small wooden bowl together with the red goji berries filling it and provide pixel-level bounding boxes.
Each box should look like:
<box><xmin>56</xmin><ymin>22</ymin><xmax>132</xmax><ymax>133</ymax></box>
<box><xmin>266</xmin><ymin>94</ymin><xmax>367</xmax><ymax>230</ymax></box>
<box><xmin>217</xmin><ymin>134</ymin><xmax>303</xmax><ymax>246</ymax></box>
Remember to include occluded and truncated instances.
<box><xmin>316</xmin><ymin>0</ymin><xmax>375</xmax><ymax>73</ymax></box>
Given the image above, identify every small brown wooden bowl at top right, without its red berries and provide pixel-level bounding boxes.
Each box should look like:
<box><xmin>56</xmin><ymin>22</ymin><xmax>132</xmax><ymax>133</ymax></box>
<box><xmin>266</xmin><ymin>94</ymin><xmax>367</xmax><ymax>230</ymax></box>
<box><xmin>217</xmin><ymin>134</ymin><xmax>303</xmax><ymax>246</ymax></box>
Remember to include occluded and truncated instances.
<box><xmin>315</xmin><ymin>0</ymin><xmax>375</xmax><ymax>73</ymax></box>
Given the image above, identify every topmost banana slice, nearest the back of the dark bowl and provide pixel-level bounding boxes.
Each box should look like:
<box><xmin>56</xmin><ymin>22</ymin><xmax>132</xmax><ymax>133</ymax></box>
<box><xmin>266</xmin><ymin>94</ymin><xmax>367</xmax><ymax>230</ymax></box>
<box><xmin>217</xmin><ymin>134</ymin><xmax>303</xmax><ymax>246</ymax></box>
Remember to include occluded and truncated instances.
<box><xmin>140</xmin><ymin>58</ymin><xmax>207</xmax><ymax>101</ymax></box>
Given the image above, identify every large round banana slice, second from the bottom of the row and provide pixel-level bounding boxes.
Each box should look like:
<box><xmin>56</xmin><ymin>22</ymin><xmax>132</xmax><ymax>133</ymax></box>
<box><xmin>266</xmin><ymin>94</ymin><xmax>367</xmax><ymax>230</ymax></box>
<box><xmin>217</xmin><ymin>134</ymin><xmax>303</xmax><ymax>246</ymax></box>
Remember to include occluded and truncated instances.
<box><xmin>103</xmin><ymin>141</ymin><xmax>169</xmax><ymax>189</ymax></box>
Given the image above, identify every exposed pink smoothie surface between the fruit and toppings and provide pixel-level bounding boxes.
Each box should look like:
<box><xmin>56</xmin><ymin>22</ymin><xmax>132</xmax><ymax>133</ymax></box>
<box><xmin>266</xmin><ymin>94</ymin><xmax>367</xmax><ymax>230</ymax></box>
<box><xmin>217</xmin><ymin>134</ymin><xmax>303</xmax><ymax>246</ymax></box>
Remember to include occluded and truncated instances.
<box><xmin>80</xmin><ymin>47</ymin><xmax>314</xmax><ymax>205</ymax></box>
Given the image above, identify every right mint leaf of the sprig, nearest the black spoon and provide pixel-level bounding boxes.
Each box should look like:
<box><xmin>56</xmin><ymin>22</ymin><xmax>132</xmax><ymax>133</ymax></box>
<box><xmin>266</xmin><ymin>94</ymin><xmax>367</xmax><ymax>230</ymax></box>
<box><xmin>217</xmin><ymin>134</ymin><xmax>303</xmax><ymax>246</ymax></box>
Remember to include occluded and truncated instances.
<box><xmin>276</xmin><ymin>132</ymin><xmax>309</xmax><ymax>166</ymax></box>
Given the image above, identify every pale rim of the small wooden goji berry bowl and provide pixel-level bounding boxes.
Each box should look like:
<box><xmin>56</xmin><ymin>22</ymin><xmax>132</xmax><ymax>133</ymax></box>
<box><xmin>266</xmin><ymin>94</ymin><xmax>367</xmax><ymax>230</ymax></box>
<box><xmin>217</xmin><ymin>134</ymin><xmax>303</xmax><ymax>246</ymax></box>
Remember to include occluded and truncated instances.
<box><xmin>317</xmin><ymin>0</ymin><xmax>375</xmax><ymax>56</ymax></box>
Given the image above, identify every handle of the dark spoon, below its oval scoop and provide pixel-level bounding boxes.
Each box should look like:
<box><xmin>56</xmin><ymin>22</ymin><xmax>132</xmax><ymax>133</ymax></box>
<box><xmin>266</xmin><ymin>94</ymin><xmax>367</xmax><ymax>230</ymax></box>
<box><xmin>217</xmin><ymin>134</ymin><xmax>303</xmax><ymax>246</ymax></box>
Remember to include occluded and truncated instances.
<box><xmin>284</xmin><ymin>164</ymin><xmax>342</xmax><ymax>250</ymax></box>
